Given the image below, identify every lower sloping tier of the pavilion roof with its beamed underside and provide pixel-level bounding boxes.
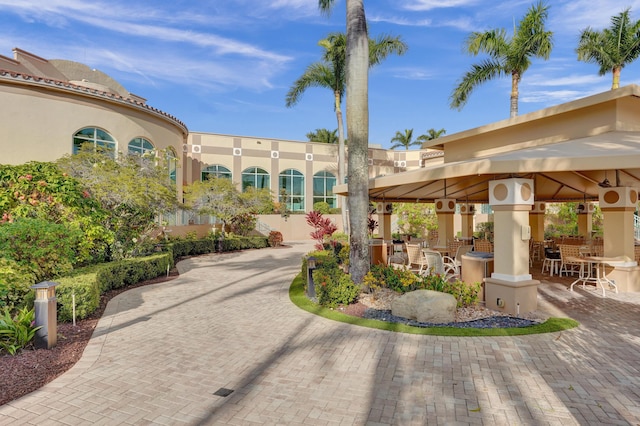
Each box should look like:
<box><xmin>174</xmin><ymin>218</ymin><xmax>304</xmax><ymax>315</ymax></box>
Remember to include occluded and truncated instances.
<box><xmin>335</xmin><ymin>131</ymin><xmax>640</xmax><ymax>203</ymax></box>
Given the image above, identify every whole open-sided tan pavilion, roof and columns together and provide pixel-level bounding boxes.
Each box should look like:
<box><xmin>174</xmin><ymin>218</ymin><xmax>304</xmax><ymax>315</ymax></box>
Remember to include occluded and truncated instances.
<box><xmin>334</xmin><ymin>85</ymin><xmax>640</xmax><ymax>313</ymax></box>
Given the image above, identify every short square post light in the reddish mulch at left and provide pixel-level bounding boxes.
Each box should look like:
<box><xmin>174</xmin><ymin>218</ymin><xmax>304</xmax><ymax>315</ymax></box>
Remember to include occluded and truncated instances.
<box><xmin>31</xmin><ymin>281</ymin><xmax>58</xmax><ymax>349</ymax></box>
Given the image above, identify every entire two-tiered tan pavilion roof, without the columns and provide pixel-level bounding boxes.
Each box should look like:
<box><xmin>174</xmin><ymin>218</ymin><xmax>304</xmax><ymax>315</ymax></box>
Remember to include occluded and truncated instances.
<box><xmin>334</xmin><ymin>85</ymin><xmax>640</xmax><ymax>203</ymax></box>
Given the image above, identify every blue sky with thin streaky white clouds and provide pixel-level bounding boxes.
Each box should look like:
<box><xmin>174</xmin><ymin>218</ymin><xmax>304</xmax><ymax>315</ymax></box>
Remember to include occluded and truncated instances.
<box><xmin>0</xmin><ymin>0</ymin><xmax>640</xmax><ymax>147</ymax></box>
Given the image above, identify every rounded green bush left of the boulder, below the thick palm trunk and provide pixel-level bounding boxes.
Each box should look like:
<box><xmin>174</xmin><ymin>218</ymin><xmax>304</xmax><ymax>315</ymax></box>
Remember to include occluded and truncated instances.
<box><xmin>313</xmin><ymin>265</ymin><xmax>361</xmax><ymax>308</ymax></box>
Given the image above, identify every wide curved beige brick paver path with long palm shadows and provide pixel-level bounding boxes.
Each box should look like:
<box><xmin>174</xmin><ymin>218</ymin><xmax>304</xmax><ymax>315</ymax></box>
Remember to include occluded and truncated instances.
<box><xmin>0</xmin><ymin>243</ymin><xmax>640</xmax><ymax>426</ymax></box>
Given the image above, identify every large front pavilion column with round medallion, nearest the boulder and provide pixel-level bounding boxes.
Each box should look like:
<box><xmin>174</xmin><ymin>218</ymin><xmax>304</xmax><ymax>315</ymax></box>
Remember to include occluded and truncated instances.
<box><xmin>484</xmin><ymin>178</ymin><xmax>540</xmax><ymax>315</ymax></box>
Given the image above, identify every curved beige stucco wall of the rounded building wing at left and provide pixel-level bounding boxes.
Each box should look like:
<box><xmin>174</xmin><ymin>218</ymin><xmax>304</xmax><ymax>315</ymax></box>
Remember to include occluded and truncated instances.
<box><xmin>0</xmin><ymin>83</ymin><xmax>186</xmax><ymax>164</ymax></box>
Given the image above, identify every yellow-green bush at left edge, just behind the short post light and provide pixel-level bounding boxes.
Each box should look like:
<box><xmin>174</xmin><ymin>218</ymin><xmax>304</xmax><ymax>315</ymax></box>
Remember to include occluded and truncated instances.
<box><xmin>0</xmin><ymin>258</ymin><xmax>36</xmax><ymax>312</ymax></box>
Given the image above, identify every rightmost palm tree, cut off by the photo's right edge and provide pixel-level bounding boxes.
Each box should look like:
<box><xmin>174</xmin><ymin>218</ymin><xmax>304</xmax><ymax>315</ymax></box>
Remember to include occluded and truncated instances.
<box><xmin>576</xmin><ymin>9</ymin><xmax>640</xmax><ymax>89</ymax></box>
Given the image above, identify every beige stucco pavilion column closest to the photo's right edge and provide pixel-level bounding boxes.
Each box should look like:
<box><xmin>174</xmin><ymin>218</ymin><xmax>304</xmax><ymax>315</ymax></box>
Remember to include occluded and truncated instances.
<box><xmin>598</xmin><ymin>187</ymin><xmax>638</xmax><ymax>260</ymax></box>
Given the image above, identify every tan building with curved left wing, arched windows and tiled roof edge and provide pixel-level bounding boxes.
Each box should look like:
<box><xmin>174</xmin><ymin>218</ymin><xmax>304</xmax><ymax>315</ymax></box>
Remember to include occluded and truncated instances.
<box><xmin>0</xmin><ymin>48</ymin><xmax>456</xmax><ymax>239</ymax></box>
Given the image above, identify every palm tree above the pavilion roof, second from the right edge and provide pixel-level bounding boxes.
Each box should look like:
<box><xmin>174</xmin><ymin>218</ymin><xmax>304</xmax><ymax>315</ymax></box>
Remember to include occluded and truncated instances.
<box><xmin>450</xmin><ymin>1</ymin><xmax>553</xmax><ymax>117</ymax></box>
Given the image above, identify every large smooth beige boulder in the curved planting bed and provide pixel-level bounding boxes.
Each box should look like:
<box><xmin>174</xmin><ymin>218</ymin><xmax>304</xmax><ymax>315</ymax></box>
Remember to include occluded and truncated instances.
<box><xmin>391</xmin><ymin>290</ymin><xmax>457</xmax><ymax>323</ymax></box>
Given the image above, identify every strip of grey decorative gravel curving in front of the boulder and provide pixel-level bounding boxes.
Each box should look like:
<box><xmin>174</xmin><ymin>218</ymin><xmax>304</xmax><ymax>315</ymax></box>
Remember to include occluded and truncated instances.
<box><xmin>363</xmin><ymin>308</ymin><xmax>540</xmax><ymax>328</ymax></box>
